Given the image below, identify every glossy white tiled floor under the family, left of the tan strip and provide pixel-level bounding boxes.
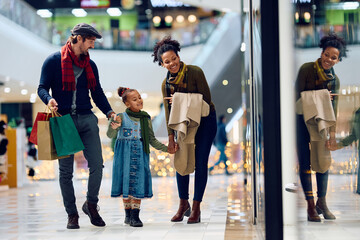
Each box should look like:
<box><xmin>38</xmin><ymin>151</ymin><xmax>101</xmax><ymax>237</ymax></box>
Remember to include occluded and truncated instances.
<box><xmin>0</xmin><ymin>175</ymin><xmax>245</xmax><ymax>240</ymax></box>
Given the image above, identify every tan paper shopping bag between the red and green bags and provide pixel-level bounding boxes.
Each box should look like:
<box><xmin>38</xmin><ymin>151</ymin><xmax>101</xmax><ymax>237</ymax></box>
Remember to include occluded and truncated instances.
<box><xmin>37</xmin><ymin>121</ymin><xmax>68</xmax><ymax>160</ymax></box>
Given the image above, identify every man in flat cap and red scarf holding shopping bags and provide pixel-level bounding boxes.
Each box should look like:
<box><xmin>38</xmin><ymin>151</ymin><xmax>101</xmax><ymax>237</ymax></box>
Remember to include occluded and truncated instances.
<box><xmin>38</xmin><ymin>23</ymin><xmax>115</xmax><ymax>229</ymax></box>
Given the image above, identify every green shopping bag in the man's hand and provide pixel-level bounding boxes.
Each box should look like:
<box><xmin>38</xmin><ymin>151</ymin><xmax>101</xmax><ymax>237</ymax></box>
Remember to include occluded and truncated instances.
<box><xmin>50</xmin><ymin>114</ymin><xmax>85</xmax><ymax>156</ymax></box>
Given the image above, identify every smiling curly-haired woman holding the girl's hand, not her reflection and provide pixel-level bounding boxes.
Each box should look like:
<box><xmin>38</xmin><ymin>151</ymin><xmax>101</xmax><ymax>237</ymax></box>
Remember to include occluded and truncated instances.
<box><xmin>152</xmin><ymin>37</ymin><xmax>217</xmax><ymax>224</ymax></box>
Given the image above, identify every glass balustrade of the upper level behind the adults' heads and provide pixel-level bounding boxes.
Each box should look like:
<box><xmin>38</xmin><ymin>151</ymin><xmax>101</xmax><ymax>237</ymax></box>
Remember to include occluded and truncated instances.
<box><xmin>0</xmin><ymin>0</ymin><xmax>221</xmax><ymax>51</ymax></box>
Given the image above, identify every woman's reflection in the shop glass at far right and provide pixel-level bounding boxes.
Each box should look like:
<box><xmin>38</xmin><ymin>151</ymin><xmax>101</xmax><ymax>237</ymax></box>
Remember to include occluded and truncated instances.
<box><xmin>296</xmin><ymin>34</ymin><xmax>347</xmax><ymax>222</ymax></box>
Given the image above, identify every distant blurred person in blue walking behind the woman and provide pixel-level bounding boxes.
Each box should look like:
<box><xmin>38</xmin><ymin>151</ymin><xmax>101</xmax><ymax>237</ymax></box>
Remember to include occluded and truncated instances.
<box><xmin>209</xmin><ymin>115</ymin><xmax>230</xmax><ymax>175</ymax></box>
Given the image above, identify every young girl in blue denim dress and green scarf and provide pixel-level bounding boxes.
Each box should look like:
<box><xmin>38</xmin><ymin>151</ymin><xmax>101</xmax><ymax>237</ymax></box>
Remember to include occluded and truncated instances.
<box><xmin>107</xmin><ymin>87</ymin><xmax>172</xmax><ymax>227</ymax></box>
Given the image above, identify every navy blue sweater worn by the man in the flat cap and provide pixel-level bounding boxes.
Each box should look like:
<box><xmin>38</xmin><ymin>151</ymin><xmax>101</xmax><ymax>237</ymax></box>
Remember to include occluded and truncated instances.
<box><xmin>38</xmin><ymin>52</ymin><xmax>112</xmax><ymax>115</ymax></box>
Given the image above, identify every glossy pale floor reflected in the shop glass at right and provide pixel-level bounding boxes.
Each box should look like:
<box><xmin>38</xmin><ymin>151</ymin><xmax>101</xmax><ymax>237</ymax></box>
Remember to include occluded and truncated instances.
<box><xmin>298</xmin><ymin>175</ymin><xmax>360</xmax><ymax>240</ymax></box>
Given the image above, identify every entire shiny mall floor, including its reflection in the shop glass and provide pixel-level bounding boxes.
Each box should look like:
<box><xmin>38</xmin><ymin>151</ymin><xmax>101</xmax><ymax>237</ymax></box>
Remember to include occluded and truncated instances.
<box><xmin>0</xmin><ymin>174</ymin><xmax>360</xmax><ymax>240</ymax></box>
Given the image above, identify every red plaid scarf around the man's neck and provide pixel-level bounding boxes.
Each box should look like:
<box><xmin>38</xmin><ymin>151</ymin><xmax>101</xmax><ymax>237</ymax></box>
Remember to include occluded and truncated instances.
<box><xmin>61</xmin><ymin>42</ymin><xmax>96</xmax><ymax>91</ymax></box>
